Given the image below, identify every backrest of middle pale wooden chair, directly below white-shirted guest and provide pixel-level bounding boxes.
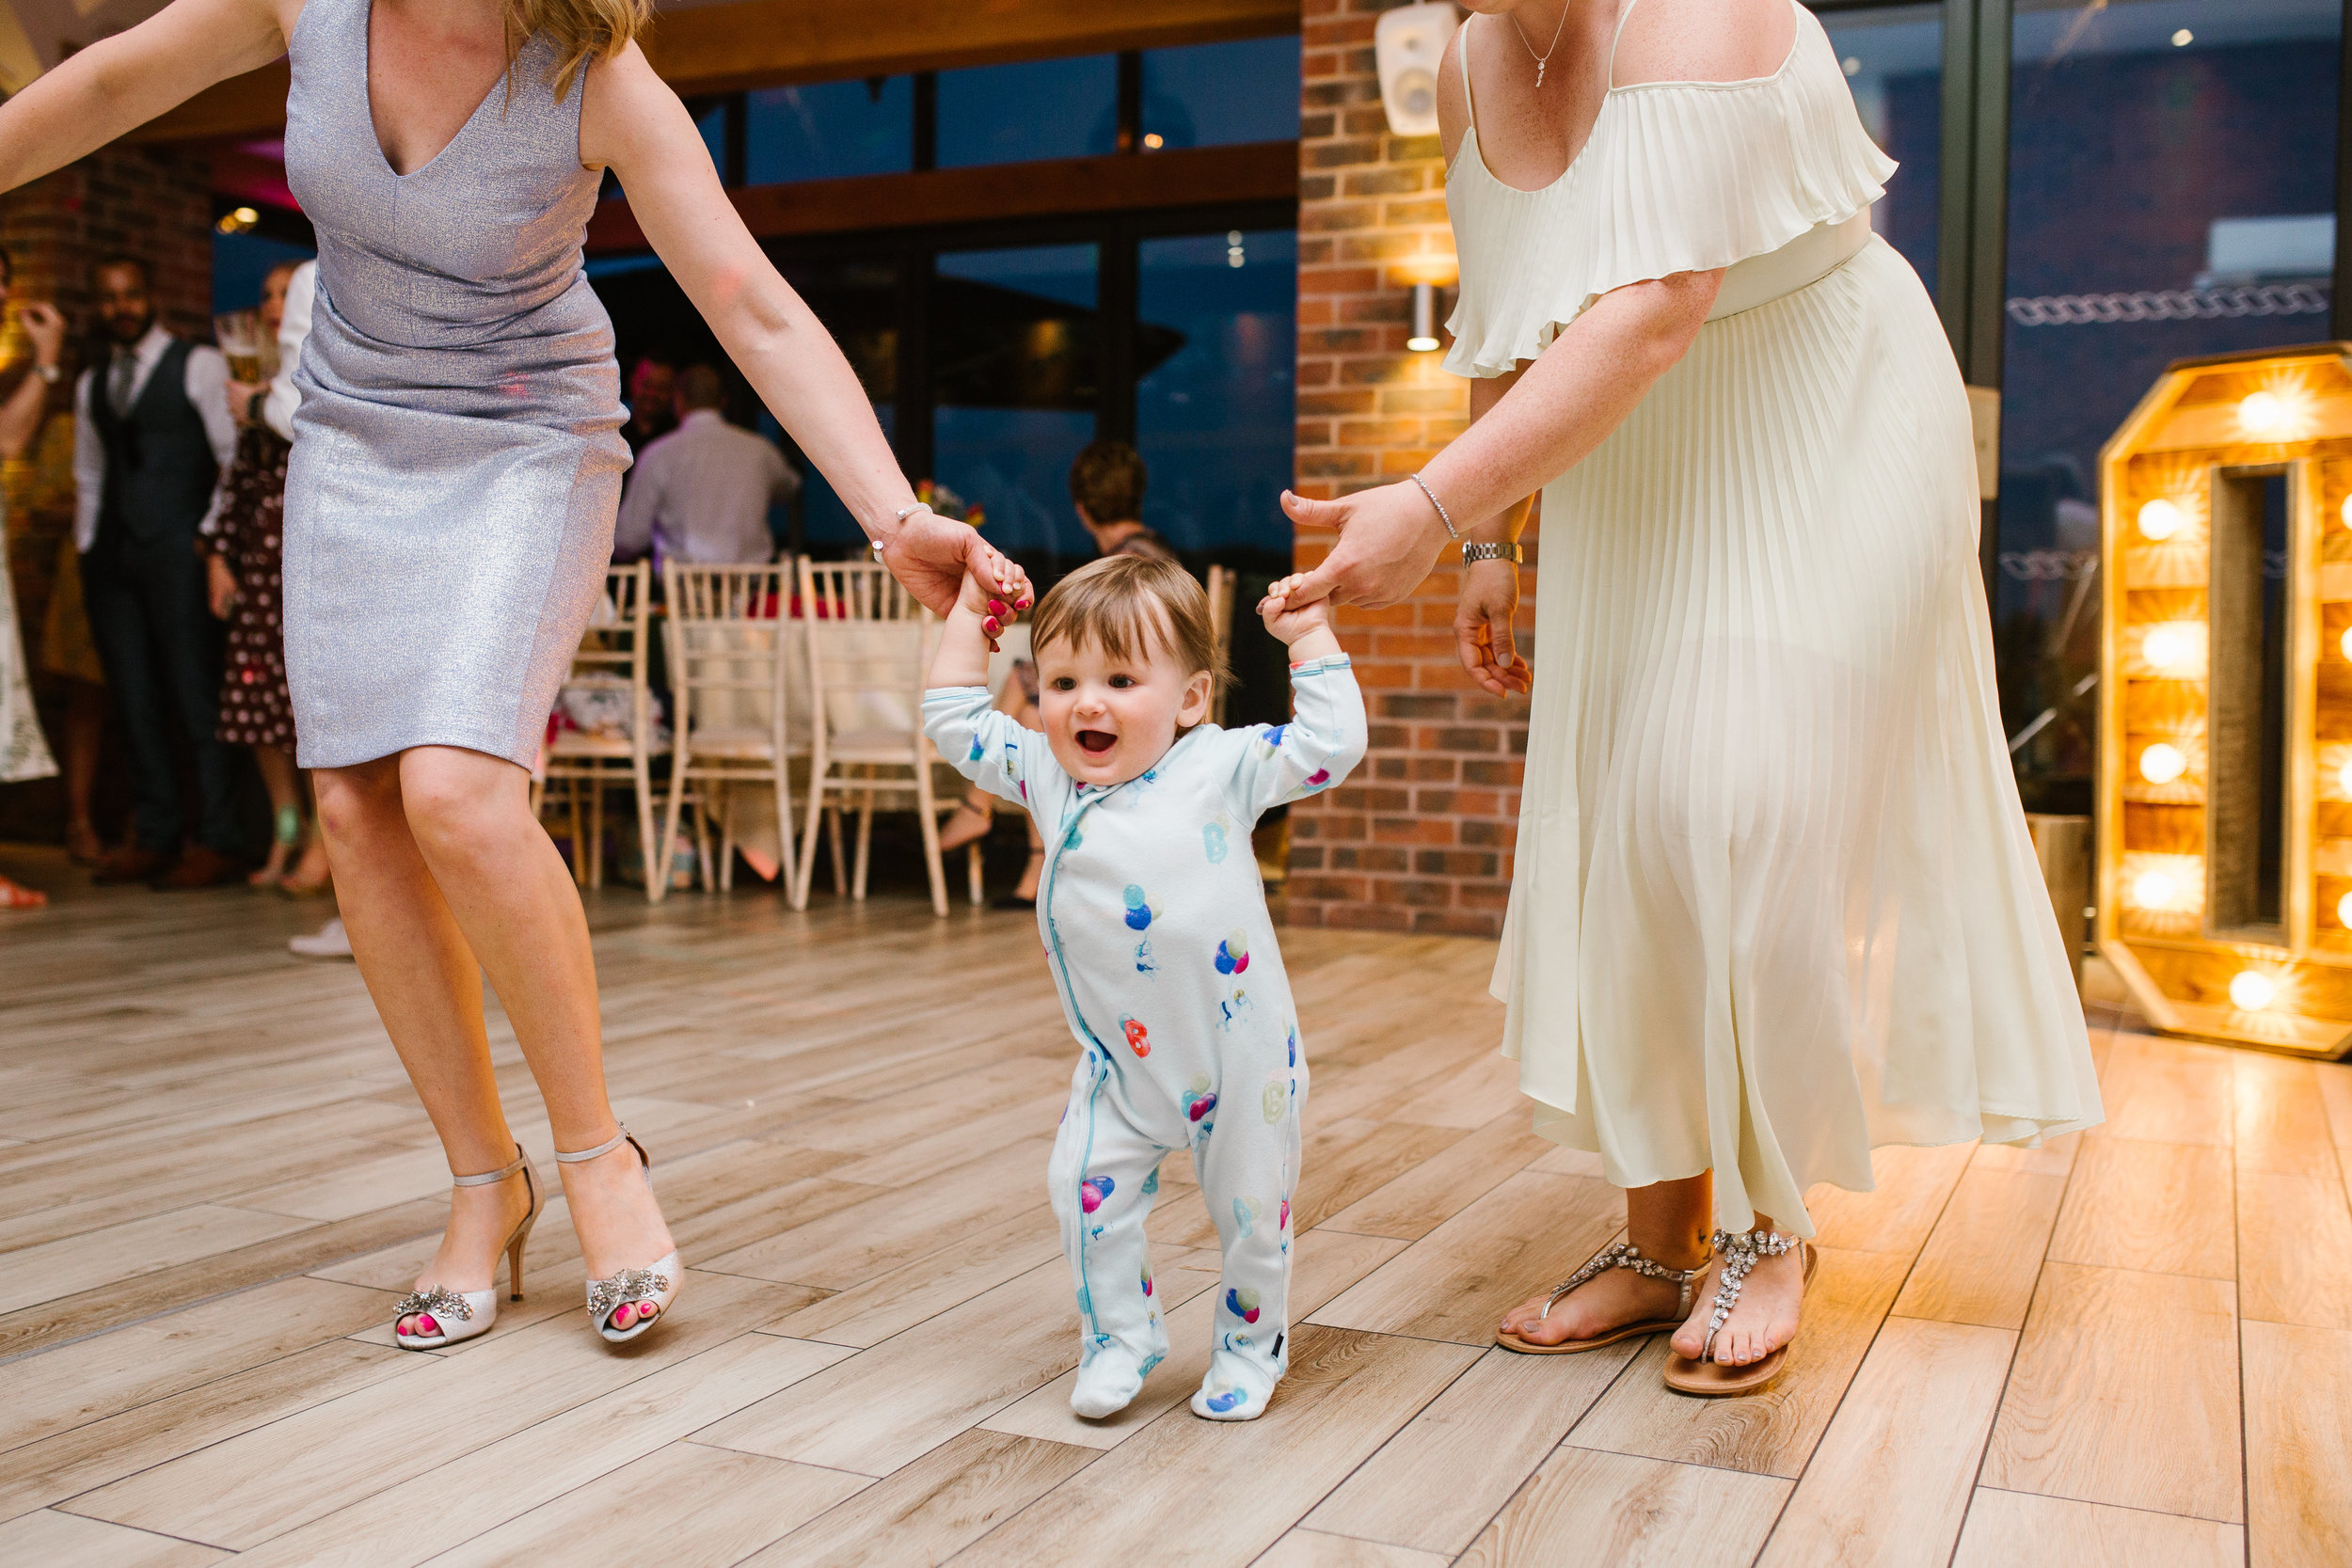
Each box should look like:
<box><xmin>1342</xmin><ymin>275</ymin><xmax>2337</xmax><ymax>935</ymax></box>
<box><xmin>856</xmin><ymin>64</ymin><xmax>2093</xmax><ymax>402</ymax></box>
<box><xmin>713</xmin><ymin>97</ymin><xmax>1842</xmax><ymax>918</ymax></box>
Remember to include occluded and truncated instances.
<box><xmin>661</xmin><ymin>562</ymin><xmax>790</xmax><ymax>748</ymax></box>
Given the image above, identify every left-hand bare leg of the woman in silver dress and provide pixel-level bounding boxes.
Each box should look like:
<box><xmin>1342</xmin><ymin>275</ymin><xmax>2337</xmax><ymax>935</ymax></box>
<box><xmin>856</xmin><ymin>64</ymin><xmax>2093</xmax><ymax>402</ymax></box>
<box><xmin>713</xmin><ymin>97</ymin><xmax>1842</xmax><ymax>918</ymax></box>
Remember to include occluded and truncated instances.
<box><xmin>315</xmin><ymin>757</ymin><xmax>530</xmax><ymax>1328</ymax></box>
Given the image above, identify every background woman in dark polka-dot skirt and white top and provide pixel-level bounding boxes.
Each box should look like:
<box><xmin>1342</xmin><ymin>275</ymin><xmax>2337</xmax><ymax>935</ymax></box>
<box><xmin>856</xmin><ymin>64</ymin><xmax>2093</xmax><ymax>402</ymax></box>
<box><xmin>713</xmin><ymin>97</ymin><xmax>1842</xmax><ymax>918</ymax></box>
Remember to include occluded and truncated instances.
<box><xmin>207</xmin><ymin>261</ymin><xmax>327</xmax><ymax>894</ymax></box>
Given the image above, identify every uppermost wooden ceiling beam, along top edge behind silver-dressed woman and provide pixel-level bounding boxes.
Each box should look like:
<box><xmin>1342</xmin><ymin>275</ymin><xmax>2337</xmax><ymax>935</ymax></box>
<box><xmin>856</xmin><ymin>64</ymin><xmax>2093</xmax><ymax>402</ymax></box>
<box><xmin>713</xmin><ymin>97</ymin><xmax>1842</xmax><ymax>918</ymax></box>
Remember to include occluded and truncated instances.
<box><xmin>130</xmin><ymin>0</ymin><xmax>1298</xmax><ymax>141</ymax></box>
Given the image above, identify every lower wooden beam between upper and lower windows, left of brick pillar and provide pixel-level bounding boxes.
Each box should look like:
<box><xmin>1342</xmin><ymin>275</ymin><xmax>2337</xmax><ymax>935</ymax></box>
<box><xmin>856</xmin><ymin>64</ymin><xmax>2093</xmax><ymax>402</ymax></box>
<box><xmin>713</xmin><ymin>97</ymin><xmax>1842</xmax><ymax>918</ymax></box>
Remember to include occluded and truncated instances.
<box><xmin>588</xmin><ymin>141</ymin><xmax>1298</xmax><ymax>254</ymax></box>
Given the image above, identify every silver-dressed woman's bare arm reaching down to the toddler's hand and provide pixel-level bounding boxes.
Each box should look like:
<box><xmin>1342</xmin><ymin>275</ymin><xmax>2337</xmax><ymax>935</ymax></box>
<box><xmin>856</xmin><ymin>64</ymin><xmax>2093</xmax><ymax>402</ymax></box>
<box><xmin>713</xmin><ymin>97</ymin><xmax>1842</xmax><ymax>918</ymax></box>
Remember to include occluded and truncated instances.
<box><xmin>581</xmin><ymin>44</ymin><xmax>1016</xmax><ymax>613</ymax></box>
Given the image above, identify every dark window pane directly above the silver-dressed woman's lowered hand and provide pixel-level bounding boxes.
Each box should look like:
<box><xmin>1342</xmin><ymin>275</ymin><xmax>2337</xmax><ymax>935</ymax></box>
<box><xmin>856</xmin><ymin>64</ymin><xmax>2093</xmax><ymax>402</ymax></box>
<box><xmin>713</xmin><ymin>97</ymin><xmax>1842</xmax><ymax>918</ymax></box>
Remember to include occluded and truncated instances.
<box><xmin>931</xmin><ymin>245</ymin><xmax>1104</xmax><ymax>563</ymax></box>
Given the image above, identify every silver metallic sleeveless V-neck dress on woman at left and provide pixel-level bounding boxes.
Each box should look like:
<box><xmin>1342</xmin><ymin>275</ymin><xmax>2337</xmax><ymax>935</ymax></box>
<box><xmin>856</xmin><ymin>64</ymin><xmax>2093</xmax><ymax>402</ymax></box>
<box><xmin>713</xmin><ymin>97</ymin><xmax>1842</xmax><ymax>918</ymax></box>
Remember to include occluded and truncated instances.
<box><xmin>285</xmin><ymin>0</ymin><xmax>628</xmax><ymax>767</ymax></box>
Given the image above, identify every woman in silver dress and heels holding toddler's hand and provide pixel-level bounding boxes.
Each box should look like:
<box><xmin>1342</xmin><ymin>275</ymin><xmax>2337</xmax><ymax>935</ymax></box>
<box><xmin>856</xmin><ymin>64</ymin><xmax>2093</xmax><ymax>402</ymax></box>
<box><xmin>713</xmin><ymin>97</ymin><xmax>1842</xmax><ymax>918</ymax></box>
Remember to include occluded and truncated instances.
<box><xmin>0</xmin><ymin>0</ymin><xmax>1028</xmax><ymax>1350</ymax></box>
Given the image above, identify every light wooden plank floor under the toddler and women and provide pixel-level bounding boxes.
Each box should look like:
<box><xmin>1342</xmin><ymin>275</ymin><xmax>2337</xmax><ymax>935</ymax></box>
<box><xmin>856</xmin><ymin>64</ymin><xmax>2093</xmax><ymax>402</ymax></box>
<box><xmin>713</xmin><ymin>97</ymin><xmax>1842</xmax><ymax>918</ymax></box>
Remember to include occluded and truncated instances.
<box><xmin>0</xmin><ymin>851</ymin><xmax>2352</xmax><ymax>1568</ymax></box>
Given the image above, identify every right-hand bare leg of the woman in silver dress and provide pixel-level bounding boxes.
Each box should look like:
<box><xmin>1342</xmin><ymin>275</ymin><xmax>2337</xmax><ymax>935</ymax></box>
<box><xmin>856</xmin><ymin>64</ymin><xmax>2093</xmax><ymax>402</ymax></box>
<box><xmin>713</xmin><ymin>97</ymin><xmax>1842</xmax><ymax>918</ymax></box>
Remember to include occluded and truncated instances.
<box><xmin>390</xmin><ymin>745</ymin><xmax>671</xmax><ymax>1328</ymax></box>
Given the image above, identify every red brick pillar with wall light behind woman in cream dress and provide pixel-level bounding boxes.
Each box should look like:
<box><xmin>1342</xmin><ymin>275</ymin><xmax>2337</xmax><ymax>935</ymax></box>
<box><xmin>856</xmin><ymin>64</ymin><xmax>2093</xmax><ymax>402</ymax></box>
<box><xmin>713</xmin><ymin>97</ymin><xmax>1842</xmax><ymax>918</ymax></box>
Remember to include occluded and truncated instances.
<box><xmin>1287</xmin><ymin>0</ymin><xmax>1534</xmax><ymax>936</ymax></box>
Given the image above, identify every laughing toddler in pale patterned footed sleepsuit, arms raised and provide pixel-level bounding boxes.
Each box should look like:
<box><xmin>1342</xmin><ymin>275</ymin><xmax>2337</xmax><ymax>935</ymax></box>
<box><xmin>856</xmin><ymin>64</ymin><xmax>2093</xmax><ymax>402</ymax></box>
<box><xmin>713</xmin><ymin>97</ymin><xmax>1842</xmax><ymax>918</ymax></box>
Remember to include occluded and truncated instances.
<box><xmin>922</xmin><ymin>555</ymin><xmax>1364</xmax><ymax>1420</ymax></box>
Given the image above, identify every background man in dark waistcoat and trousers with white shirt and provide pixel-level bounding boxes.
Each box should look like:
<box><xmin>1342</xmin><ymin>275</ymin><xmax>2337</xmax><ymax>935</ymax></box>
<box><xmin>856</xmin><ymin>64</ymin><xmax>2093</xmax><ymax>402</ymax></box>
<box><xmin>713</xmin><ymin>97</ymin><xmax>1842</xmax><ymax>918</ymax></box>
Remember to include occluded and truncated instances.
<box><xmin>73</xmin><ymin>256</ymin><xmax>243</xmax><ymax>886</ymax></box>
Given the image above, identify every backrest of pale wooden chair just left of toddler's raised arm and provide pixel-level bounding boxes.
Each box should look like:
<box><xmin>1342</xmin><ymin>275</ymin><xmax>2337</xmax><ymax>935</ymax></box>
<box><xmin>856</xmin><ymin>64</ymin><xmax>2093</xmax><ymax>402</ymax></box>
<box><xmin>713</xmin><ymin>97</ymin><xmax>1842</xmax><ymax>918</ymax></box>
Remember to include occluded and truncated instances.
<box><xmin>798</xmin><ymin>557</ymin><xmax>939</xmax><ymax>734</ymax></box>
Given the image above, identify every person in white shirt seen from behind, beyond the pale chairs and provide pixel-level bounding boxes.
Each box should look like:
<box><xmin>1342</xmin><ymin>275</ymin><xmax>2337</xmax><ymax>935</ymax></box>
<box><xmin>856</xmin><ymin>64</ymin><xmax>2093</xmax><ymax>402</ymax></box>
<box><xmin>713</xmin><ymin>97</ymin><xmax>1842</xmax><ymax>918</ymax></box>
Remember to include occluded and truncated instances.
<box><xmin>612</xmin><ymin>364</ymin><xmax>800</xmax><ymax>569</ymax></box>
